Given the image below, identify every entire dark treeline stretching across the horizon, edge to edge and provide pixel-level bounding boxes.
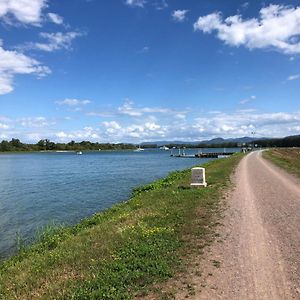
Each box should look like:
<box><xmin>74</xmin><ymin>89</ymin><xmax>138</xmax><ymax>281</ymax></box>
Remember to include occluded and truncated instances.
<box><xmin>0</xmin><ymin>135</ymin><xmax>300</xmax><ymax>152</ymax></box>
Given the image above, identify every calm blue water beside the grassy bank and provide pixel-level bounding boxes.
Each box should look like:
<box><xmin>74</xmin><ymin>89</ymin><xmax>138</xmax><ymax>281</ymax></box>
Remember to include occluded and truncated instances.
<box><xmin>0</xmin><ymin>149</ymin><xmax>239</xmax><ymax>259</ymax></box>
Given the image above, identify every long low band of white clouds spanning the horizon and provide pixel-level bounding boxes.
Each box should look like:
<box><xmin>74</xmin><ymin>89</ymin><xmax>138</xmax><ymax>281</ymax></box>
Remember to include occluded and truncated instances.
<box><xmin>0</xmin><ymin>109</ymin><xmax>300</xmax><ymax>143</ymax></box>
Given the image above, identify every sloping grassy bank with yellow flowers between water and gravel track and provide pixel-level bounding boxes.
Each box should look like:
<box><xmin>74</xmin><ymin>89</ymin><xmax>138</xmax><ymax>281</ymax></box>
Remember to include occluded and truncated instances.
<box><xmin>0</xmin><ymin>155</ymin><xmax>241</xmax><ymax>300</ymax></box>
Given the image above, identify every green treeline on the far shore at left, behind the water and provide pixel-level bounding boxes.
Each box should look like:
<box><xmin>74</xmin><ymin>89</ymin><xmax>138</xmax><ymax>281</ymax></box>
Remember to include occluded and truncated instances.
<box><xmin>0</xmin><ymin>139</ymin><xmax>136</xmax><ymax>152</ymax></box>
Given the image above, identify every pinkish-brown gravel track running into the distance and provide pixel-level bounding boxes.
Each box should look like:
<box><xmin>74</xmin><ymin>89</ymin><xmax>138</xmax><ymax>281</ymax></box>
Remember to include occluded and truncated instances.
<box><xmin>191</xmin><ymin>152</ymin><xmax>300</xmax><ymax>300</ymax></box>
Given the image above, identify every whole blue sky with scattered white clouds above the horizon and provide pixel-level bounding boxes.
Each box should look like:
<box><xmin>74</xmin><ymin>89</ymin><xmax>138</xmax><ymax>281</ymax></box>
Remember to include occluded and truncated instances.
<box><xmin>0</xmin><ymin>0</ymin><xmax>300</xmax><ymax>143</ymax></box>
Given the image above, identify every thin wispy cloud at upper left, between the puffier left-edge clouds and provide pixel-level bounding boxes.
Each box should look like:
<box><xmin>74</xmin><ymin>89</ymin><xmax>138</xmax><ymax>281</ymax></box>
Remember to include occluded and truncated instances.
<box><xmin>19</xmin><ymin>31</ymin><xmax>84</xmax><ymax>52</ymax></box>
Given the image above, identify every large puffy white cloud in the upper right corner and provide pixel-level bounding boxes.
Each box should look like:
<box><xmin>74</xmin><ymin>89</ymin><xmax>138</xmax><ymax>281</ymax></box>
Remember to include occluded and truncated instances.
<box><xmin>194</xmin><ymin>5</ymin><xmax>300</xmax><ymax>54</ymax></box>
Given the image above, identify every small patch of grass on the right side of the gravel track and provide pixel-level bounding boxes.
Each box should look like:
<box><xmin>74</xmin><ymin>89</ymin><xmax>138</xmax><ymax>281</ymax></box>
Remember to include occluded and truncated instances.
<box><xmin>263</xmin><ymin>148</ymin><xmax>300</xmax><ymax>177</ymax></box>
